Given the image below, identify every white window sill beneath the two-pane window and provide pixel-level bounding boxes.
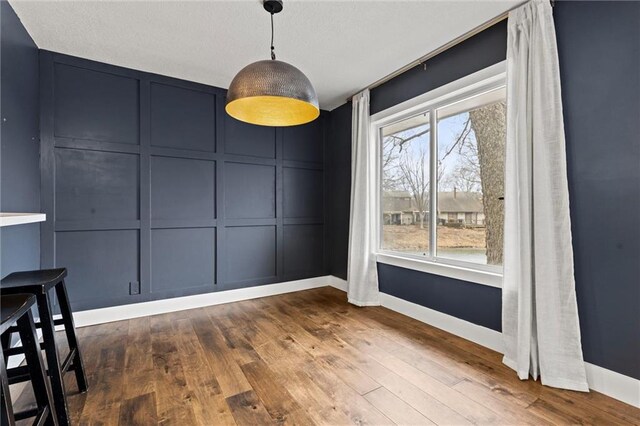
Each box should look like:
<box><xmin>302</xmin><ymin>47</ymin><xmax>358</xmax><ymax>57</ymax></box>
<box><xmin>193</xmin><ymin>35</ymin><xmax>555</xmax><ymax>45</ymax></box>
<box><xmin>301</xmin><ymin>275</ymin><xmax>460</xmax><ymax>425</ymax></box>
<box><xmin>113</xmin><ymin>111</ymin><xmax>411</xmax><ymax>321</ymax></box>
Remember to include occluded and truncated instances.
<box><xmin>376</xmin><ymin>253</ymin><xmax>502</xmax><ymax>288</ymax></box>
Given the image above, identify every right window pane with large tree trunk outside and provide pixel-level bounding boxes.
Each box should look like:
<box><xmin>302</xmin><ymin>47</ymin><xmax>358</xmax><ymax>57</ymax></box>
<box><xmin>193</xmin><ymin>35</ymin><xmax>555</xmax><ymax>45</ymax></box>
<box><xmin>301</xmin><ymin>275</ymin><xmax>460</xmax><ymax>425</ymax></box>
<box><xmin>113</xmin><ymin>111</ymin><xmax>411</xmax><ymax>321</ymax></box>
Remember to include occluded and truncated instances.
<box><xmin>435</xmin><ymin>89</ymin><xmax>506</xmax><ymax>266</ymax></box>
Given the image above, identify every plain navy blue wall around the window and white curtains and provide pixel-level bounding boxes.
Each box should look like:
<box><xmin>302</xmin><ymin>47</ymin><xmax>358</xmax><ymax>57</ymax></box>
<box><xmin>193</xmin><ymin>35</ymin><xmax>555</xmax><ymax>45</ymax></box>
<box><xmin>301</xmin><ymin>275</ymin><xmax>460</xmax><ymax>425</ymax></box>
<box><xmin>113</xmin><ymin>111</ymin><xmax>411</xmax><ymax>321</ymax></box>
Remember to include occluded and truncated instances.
<box><xmin>327</xmin><ymin>1</ymin><xmax>640</xmax><ymax>379</ymax></box>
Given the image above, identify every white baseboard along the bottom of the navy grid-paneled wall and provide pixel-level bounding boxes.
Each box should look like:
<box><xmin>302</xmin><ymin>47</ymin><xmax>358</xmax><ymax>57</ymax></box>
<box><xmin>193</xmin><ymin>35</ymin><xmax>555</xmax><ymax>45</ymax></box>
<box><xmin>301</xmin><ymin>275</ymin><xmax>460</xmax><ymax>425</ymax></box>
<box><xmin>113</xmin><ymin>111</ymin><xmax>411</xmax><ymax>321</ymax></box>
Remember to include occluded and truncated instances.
<box><xmin>73</xmin><ymin>276</ymin><xmax>332</xmax><ymax>327</ymax></box>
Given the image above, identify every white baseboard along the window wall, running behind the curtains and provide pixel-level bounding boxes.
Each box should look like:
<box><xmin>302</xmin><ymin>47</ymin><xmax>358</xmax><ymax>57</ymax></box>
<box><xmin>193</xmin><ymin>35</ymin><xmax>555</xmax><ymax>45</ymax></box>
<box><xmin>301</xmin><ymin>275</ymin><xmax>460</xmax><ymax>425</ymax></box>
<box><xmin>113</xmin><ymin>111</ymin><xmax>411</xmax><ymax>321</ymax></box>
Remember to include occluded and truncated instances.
<box><xmin>329</xmin><ymin>276</ymin><xmax>640</xmax><ymax>408</ymax></box>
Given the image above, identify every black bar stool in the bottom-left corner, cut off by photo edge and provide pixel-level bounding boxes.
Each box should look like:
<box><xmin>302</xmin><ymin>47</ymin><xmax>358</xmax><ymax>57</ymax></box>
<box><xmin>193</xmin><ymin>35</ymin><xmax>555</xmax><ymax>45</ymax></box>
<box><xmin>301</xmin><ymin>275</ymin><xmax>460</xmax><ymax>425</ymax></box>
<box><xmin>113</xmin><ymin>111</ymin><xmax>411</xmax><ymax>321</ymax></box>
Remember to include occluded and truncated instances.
<box><xmin>0</xmin><ymin>294</ymin><xmax>58</xmax><ymax>426</ymax></box>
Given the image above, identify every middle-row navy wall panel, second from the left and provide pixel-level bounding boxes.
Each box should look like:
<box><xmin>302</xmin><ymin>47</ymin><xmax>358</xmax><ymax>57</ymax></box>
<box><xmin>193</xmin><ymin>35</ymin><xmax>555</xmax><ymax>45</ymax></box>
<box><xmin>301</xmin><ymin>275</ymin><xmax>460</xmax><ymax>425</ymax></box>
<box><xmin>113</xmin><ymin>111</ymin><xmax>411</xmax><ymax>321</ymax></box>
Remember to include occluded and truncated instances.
<box><xmin>151</xmin><ymin>156</ymin><xmax>216</xmax><ymax>220</ymax></box>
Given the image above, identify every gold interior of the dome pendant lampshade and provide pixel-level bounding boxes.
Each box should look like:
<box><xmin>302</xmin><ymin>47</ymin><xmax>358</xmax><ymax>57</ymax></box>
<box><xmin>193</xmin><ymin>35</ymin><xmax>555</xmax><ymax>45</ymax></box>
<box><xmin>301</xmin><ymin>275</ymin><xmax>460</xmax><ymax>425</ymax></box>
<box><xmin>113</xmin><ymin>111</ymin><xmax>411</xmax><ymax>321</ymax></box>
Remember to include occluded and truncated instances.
<box><xmin>225</xmin><ymin>96</ymin><xmax>320</xmax><ymax>127</ymax></box>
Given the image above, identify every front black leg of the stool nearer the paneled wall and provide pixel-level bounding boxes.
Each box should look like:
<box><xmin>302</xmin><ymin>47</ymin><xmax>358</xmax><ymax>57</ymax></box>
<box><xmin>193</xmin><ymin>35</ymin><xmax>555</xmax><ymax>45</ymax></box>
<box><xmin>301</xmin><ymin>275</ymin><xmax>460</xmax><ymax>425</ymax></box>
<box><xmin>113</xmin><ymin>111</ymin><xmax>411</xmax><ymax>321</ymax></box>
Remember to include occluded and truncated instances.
<box><xmin>37</xmin><ymin>292</ymin><xmax>70</xmax><ymax>426</ymax></box>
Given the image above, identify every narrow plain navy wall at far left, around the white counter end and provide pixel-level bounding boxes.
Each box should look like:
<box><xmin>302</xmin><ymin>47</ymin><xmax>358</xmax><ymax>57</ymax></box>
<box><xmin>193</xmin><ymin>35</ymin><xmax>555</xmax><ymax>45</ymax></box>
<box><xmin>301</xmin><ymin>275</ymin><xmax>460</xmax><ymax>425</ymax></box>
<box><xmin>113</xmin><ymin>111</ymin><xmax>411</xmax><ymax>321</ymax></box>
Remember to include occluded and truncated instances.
<box><xmin>0</xmin><ymin>0</ymin><xmax>40</xmax><ymax>277</ymax></box>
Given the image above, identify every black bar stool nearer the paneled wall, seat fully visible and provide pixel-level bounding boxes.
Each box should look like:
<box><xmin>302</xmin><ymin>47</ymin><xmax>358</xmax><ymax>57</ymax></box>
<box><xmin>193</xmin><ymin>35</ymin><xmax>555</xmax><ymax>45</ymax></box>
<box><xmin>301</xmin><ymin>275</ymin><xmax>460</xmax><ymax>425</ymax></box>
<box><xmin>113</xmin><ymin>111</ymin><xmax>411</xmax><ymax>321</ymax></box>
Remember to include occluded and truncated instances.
<box><xmin>0</xmin><ymin>268</ymin><xmax>87</xmax><ymax>426</ymax></box>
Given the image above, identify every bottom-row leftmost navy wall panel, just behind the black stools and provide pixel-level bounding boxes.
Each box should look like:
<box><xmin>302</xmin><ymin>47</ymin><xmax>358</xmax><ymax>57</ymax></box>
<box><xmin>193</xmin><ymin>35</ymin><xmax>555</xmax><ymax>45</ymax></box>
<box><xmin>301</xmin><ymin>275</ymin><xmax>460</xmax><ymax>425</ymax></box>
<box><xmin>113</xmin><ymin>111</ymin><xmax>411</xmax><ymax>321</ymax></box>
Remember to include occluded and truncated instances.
<box><xmin>56</xmin><ymin>230</ymin><xmax>139</xmax><ymax>310</ymax></box>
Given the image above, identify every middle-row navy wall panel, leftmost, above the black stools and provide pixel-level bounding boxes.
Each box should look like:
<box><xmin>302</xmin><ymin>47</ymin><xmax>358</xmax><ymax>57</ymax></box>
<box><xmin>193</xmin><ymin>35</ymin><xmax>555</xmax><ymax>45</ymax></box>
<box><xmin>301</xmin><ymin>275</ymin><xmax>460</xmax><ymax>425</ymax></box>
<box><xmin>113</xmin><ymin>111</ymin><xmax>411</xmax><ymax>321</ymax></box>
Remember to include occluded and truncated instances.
<box><xmin>55</xmin><ymin>149</ymin><xmax>139</xmax><ymax>221</ymax></box>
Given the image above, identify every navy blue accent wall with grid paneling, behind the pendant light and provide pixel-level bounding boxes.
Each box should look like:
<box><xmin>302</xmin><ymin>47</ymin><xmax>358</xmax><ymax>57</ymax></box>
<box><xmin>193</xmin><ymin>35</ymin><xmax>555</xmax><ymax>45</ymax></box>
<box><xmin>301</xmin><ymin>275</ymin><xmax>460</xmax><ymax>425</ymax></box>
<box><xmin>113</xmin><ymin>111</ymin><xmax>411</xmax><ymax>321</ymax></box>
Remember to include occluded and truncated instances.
<box><xmin>40</xmin><ymin>51</ymin><xmax>326</xmax><ymax>310</ymax></box>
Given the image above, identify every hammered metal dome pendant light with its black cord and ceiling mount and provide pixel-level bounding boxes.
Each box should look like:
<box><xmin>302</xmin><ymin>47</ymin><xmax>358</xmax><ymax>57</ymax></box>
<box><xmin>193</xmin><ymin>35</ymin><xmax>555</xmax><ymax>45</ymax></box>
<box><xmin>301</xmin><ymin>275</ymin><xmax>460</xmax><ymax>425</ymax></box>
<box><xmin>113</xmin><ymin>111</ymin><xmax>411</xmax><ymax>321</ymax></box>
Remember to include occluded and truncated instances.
<box><xmin>225</xmin><ymin>0</ymin><xmax>320</xmax><ymax>127</ymax></box>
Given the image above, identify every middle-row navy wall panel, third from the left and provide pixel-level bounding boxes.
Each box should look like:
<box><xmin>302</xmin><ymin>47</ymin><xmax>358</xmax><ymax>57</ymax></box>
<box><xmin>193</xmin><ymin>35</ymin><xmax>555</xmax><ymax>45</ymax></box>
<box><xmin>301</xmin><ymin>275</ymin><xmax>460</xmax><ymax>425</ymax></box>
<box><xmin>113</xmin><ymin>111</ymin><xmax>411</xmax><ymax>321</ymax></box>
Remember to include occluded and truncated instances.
<box><xmin>224</xmin><ymin>163</ymin><xmax>276</xmax><ymax>219</ymax></box>
